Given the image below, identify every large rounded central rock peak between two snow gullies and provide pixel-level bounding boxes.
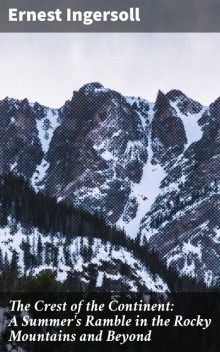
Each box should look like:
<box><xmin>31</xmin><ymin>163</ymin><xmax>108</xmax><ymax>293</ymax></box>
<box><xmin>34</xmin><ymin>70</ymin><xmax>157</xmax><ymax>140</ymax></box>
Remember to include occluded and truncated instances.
<box><xmin>45</xmin><ymin>84</ymin><xmax>148</xmax><ymax>223</ymax></box>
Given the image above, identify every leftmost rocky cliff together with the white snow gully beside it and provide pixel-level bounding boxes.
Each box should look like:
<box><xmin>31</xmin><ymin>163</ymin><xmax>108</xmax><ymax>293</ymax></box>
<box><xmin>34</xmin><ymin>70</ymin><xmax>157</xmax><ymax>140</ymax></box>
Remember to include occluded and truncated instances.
<box><xmin>0</xmin><ymin>98</ymin><xmax>58</xmax><ymax>185</ymax></box>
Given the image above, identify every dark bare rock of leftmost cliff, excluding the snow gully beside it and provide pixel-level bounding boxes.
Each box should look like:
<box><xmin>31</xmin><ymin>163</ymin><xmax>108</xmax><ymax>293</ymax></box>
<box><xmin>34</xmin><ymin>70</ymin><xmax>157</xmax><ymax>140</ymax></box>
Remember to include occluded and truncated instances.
<box><xmin>0</xmin><ymin>98</ymin><xmax>43</xmax><ymax>178</ymax></box>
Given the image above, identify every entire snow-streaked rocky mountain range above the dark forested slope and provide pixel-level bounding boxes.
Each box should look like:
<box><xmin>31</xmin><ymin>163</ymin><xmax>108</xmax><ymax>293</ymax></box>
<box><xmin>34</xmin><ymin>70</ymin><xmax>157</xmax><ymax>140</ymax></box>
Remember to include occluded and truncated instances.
<box><xmin>0</xmin><ymin>83</ymin><xmax>220</xmax><ymax>286</ymax></box>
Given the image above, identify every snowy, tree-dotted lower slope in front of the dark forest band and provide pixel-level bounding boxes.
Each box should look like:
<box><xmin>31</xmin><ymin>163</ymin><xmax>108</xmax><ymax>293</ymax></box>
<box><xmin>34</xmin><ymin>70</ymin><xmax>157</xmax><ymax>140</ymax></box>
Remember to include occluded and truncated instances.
<box><xmin>0</xmin><ymin>227</ymin><xmax>169</xmax><ymax>292</ymax></box>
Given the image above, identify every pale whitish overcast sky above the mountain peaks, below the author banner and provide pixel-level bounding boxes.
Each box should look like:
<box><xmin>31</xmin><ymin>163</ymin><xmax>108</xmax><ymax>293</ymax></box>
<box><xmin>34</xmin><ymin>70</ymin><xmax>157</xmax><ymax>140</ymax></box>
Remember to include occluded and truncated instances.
<box><xmin>0</xmin><ymin>33</ymin><xmax>220</xmax><ymax>107</ymax></box>
